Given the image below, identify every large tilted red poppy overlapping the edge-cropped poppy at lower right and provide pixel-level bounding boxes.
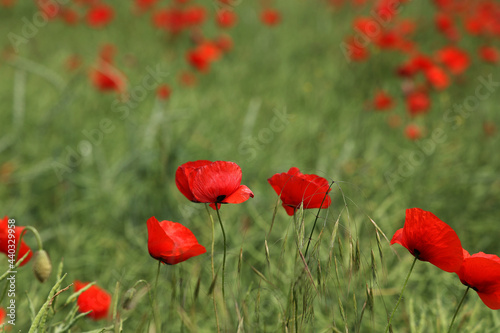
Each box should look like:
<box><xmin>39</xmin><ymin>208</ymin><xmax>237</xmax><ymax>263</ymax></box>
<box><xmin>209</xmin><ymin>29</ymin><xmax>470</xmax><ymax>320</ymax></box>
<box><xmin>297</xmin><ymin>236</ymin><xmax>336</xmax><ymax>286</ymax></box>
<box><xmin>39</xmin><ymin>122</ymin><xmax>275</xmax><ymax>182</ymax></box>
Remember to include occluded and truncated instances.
<box><xmin>391</xmin><ymin>208</ymin><xmax>463</xmax><ymax>273</ymax></box>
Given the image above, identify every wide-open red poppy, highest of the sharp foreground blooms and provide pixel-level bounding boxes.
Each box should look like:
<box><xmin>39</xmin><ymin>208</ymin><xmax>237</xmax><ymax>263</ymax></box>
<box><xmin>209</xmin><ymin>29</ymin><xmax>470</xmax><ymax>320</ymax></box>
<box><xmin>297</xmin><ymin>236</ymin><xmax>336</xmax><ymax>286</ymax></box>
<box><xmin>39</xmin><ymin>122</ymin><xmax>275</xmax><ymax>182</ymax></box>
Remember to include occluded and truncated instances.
<box><xmin>175</xmin><ymin>160</ymin><xmax>254</xmax><ymax>209</ymax></box>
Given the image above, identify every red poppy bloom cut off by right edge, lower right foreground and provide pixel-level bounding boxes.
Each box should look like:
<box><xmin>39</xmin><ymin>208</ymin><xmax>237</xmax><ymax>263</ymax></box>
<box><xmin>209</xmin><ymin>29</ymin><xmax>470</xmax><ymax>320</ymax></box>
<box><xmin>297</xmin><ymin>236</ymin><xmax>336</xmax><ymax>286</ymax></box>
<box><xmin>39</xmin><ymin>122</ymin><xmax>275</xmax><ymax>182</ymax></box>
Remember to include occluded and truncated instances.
<box><xmin>457</xmin><ymin>250</ymin><xmax>500</xmax><ymax>310</ymax></box>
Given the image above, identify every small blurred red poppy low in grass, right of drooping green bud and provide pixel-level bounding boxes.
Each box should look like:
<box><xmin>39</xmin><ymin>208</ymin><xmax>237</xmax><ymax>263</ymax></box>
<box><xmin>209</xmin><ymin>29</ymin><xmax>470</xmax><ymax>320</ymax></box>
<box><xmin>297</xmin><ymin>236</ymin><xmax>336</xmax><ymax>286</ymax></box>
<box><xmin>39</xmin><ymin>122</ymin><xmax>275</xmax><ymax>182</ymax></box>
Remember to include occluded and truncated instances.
<box><xmin>75</xmin><ymin>281</ymin><xmax>111</xmax><ymax>320</ymax></box>
